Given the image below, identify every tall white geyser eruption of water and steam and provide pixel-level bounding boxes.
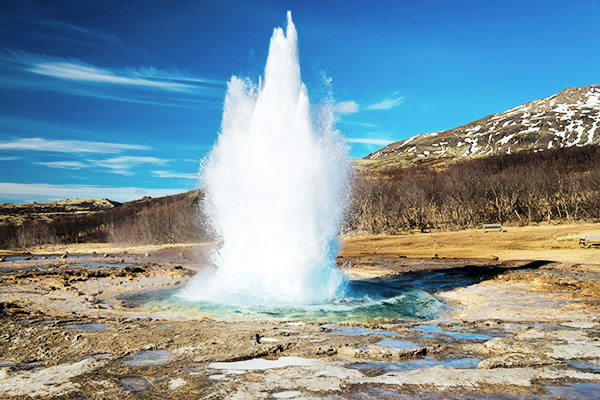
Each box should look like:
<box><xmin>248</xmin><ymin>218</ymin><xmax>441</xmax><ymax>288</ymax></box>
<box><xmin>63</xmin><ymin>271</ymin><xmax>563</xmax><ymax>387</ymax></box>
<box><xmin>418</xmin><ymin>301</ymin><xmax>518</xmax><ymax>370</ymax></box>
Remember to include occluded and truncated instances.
<box><xmin>181</xmin><ymin>12</ymin><xmax>349</xmax><ymax>305</ymax></box>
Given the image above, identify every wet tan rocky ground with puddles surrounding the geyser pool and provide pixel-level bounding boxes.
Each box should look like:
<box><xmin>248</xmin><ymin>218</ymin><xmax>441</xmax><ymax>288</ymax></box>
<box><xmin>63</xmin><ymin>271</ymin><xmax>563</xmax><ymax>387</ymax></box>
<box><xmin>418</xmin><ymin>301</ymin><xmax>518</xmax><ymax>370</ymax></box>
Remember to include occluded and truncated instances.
<box><xmin>0</xmin><ymin>230</ymin><xmax>600</xmax><ymax>400</ymax></box>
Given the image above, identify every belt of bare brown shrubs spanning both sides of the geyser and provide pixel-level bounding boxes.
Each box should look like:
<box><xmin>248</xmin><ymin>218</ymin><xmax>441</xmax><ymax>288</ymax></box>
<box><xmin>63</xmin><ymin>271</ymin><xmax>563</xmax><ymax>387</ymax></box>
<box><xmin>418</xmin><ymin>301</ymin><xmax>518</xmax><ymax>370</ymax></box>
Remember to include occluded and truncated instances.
<box><xmin>0</xmin><ymin>146</ymin><xmax>600</xmax><ymax>249</ymax></box>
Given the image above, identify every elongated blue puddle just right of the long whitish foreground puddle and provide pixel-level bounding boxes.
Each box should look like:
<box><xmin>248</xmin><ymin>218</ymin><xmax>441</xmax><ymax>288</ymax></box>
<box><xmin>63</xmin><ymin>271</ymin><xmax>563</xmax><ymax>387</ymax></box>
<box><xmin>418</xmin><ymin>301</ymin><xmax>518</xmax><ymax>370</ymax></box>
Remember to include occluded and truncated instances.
<box><xmin>348</xmin><ymin>357</ymin><xmax>481</xmax><ymax>375</ymax></box>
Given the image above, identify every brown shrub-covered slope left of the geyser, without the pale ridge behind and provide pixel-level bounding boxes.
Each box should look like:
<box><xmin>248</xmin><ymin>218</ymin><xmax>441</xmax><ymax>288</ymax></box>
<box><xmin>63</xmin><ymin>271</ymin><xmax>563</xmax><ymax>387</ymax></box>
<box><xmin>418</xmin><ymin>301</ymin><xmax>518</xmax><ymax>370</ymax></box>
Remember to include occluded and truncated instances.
<box><xmin>0</xmin><ymin>191</ymin><xmax>208</xmax><ymax>249</ymax></box>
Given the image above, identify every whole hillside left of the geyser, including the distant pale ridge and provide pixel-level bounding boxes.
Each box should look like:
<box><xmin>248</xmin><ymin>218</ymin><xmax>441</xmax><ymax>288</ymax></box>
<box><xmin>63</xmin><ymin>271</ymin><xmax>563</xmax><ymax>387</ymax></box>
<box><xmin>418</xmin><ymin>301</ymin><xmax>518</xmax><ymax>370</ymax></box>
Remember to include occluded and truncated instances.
<box><xmin>0</xmin><ymin>190</ymin><xmax>206</xmax><ymax>249</ymax></box>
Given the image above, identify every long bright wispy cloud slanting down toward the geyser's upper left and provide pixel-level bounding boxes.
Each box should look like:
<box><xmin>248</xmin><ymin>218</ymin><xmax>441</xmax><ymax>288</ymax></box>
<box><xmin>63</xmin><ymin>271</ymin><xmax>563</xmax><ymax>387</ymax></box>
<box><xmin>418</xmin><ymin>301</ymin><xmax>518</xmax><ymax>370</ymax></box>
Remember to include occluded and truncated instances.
<box><xmin>0</xmin><ymin>49</ymin><xmax>225</xmax><ymax>108</ymax></box>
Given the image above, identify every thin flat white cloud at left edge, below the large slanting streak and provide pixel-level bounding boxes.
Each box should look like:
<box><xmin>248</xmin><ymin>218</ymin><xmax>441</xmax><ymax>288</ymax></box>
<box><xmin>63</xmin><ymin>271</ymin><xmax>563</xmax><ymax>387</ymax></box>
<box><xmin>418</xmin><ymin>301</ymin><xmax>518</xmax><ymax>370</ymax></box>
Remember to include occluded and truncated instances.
<box><xmin>0</xmin><ymin>138</ymin><xmax>150</xmax><ymax>154</ymax></box>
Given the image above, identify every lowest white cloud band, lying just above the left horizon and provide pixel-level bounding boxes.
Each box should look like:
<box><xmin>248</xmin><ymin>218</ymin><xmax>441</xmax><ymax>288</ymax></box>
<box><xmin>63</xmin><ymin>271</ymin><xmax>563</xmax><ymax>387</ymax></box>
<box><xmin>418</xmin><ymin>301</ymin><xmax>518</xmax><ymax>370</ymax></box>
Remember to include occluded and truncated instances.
<box><xmin>0</xmin><ymin>182</ymin><xmax>188</xmax><ymax>202</ymax></box>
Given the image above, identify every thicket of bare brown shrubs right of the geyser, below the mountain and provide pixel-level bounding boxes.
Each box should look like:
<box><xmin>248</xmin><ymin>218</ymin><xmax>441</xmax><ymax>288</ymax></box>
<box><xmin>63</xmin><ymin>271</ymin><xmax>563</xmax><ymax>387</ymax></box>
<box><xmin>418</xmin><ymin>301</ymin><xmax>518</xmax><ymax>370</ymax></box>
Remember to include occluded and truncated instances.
<box><xmin>344</xmin><ymin>146</ymin><xmax>600</xmax><ymax>234</ymax></box>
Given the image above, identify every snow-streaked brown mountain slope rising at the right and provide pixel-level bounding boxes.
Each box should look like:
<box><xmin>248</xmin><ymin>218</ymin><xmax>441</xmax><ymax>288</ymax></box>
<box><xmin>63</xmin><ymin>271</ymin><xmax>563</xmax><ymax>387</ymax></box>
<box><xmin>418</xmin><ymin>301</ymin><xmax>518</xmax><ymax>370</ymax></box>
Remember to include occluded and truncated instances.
<box><xmin>365</xmin><ymin>85</ymin><xmax>600</xmax><ymax>164</ymax></box>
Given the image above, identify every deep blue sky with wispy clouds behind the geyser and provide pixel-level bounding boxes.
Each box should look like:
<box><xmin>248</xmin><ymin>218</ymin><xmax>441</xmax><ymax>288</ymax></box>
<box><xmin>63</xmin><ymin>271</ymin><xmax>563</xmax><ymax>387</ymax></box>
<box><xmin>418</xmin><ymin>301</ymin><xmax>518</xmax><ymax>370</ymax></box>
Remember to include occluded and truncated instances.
<box><xmin>0</xmin><ymin>0</ymin><xmax>600</xmax><ymax>202</ymax></box>
